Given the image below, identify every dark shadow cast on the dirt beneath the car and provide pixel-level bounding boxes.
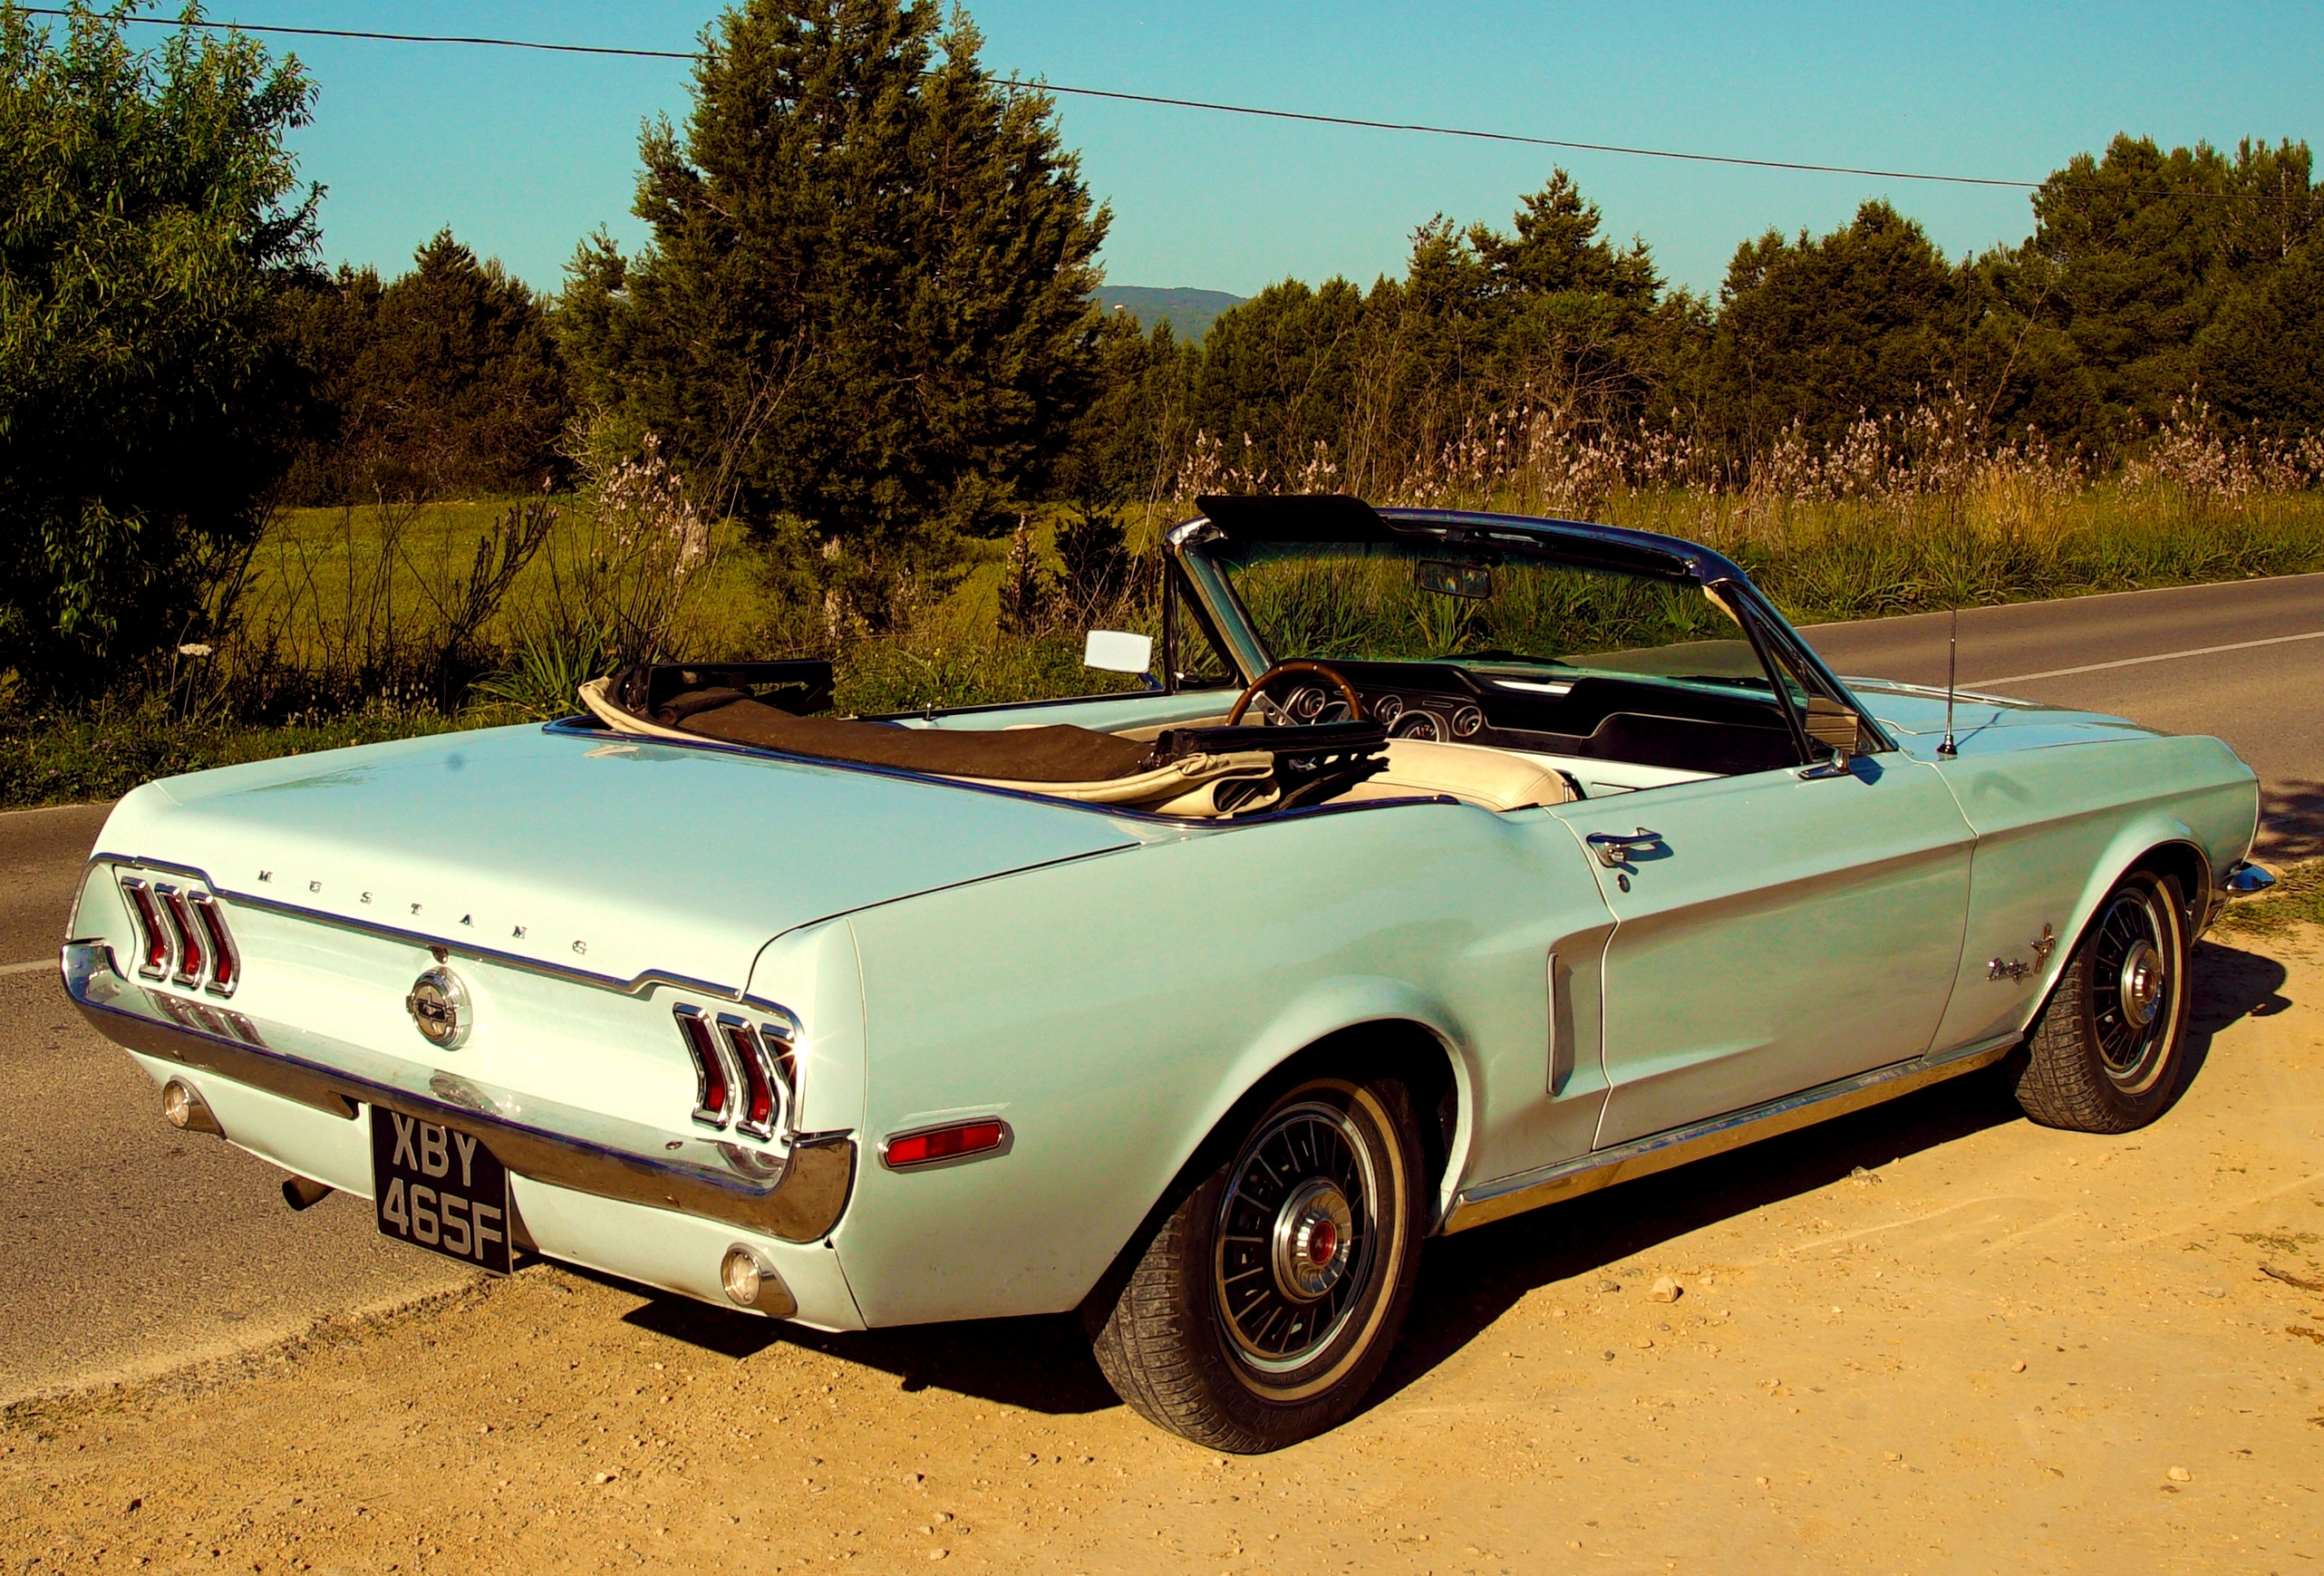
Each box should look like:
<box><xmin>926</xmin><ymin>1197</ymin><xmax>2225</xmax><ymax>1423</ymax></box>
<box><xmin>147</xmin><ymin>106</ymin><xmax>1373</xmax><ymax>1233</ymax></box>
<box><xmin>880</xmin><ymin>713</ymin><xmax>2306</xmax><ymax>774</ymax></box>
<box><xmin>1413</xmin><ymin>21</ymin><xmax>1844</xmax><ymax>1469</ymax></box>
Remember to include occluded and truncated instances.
<box><xmin>613</xmin><ymin>942</ymin><xmax>2290</xmax><ymax>1416</ymax></box>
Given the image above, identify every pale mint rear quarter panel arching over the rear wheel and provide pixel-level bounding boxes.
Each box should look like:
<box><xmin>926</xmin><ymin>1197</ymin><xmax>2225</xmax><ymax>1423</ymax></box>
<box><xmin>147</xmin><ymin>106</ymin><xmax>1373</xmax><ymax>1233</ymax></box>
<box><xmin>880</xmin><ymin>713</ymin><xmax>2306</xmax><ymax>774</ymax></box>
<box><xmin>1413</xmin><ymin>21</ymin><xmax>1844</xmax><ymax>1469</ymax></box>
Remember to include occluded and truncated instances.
<box><xmin>834</xmin><ymin>804</ymin><xmax>1608</xmax><ymax>1325</ymax></box>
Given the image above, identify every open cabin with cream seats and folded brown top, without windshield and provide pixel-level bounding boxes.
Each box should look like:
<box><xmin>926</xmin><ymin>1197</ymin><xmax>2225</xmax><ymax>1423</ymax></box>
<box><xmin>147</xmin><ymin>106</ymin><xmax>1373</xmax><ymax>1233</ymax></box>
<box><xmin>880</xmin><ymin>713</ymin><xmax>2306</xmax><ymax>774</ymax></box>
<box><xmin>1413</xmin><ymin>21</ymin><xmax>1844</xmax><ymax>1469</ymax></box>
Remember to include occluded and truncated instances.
<box><xmin>581</xmin><ymin>636</ymin><xmax>1796</xmax><ymax>818</ymax></box>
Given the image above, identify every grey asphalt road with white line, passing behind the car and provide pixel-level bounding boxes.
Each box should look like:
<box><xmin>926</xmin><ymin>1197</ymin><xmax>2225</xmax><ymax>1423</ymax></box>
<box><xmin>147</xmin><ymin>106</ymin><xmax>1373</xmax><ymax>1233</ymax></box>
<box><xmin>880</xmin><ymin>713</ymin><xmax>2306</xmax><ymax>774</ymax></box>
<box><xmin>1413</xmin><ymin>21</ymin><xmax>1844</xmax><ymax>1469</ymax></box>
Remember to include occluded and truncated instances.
<box><xmin>0</xmin><ymin>575</ymin><xmax>2324</xmax><ymax>1404</ymax></box>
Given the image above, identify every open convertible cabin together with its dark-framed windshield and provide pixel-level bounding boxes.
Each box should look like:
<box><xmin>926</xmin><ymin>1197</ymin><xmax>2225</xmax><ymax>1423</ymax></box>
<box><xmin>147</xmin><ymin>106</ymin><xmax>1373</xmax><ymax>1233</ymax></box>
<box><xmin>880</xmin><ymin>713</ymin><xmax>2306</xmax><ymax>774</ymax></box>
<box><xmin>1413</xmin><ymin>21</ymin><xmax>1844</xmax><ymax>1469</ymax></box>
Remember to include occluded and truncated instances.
<box><xmin>581</xmin><ymin>498</ymin><xmax>1854</xmax><ymax>818</ymax></box>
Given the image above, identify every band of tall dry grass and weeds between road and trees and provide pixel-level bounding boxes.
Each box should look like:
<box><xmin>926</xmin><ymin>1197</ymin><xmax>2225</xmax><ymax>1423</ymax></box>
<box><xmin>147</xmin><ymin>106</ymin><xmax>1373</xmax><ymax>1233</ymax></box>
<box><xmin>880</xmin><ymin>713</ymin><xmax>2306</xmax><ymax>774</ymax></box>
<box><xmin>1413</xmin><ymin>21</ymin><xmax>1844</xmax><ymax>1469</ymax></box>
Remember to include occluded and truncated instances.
<box><xmin>0</xmin><ymin>395</ymin><xmax>2324</xmax><ymax>804</ymax></box>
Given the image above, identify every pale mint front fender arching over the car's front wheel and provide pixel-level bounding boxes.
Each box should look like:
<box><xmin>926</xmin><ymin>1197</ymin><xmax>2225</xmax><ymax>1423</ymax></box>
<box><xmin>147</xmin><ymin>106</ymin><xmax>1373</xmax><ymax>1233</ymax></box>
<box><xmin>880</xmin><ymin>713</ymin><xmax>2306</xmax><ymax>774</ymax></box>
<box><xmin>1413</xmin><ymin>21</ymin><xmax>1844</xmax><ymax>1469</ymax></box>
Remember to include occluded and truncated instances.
<box><xmin>1936</xmin><ymin>735</ymin><xmax>2259</xmax><ymax>1049</ymax></box>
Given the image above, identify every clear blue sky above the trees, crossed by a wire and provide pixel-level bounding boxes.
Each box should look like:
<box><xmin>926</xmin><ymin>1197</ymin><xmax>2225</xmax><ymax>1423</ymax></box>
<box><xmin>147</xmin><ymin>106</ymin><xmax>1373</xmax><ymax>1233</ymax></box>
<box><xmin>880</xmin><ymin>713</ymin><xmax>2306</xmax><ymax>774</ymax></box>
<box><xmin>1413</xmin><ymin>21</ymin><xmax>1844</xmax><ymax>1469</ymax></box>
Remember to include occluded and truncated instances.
<box><xmin>176</xmin><ymin>0</ymin><xmax>2324</xmax><ymax>295</ymax></box>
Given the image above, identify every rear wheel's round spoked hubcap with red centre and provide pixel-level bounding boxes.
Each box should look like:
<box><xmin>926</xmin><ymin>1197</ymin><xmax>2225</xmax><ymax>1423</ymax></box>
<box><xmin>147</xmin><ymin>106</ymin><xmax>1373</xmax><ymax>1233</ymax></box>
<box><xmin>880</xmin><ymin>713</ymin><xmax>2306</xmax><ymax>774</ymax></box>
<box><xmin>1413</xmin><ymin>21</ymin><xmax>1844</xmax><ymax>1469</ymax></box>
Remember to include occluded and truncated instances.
<box><xmin>1215</xmin><ymin>1102</ymin><xmax>1378</xmax><ymax>1374</ymax></box>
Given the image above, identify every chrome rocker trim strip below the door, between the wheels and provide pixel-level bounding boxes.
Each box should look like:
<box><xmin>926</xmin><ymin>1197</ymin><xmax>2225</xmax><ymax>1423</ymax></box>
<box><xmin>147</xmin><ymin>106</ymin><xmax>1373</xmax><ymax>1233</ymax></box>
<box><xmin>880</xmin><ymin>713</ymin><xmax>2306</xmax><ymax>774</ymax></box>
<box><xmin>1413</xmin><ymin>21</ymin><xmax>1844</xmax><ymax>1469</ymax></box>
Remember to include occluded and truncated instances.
<box><xmin>1437</xmin><ymin>1034</ymin><xmax>2022</xmax><ymax>1234</ymax></box>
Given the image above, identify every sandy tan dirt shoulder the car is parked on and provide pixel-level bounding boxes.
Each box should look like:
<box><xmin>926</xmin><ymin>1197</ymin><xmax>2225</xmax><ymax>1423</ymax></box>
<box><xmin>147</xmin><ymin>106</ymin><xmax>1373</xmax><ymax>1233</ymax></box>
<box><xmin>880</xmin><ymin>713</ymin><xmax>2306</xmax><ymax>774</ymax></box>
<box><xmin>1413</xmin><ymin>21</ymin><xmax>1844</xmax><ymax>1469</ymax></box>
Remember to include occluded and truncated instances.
<box><xmin>0</xmin><ymin>930</ymin><xmax>2324</xmax><ymax>1573</ymax></box>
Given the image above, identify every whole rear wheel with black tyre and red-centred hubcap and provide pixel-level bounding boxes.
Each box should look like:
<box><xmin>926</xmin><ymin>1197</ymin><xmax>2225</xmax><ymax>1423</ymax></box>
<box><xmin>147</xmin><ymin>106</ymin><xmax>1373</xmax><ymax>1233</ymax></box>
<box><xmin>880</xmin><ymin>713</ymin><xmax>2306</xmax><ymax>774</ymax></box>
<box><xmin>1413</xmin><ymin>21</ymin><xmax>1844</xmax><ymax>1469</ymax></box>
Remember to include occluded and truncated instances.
<box><xmin>1092</xmin><ymin>1077</ymin><xmax>1427</xmax><ymax>1455</ymax></box>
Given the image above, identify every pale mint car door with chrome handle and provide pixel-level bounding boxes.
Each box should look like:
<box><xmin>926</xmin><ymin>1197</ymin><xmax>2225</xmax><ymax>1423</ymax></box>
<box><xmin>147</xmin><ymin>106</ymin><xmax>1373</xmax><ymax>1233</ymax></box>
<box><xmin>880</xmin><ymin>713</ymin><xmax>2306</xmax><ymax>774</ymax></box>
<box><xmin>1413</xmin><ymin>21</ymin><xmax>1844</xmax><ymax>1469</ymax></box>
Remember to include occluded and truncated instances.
<box><xmin>1550</xmin><ymin>750</ymin><xmax>1973</xmax><ymax>1148</ymax></box>
